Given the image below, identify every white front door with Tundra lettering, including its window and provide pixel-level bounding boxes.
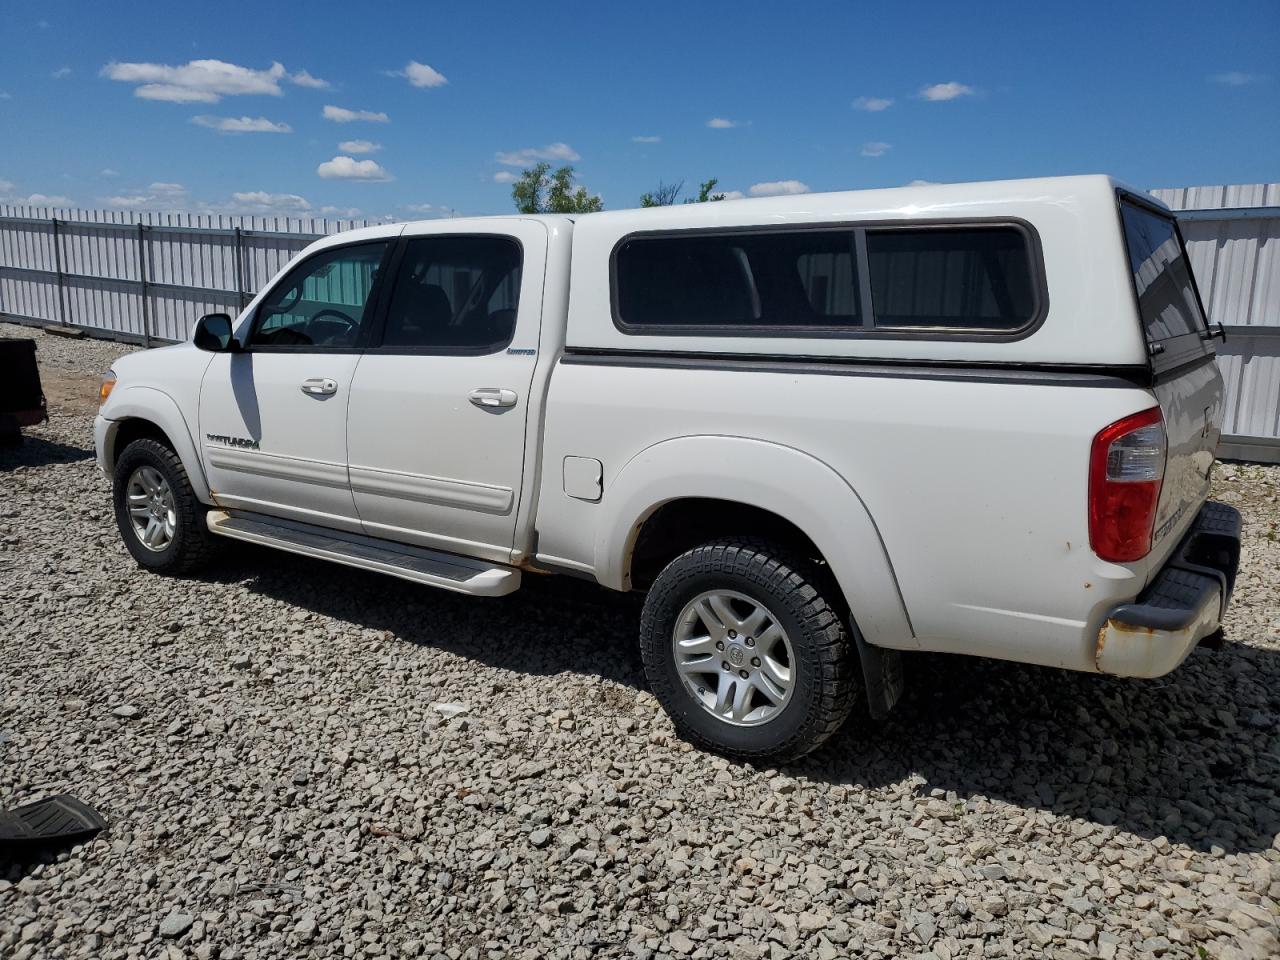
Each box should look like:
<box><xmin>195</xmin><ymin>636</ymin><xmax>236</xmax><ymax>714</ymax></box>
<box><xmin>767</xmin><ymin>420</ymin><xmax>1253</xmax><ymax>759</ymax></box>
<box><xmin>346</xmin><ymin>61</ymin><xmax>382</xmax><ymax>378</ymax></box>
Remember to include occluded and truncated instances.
<box><xmin>200</xmin><ymin>241</ymin><xmax>390</xmax><ymax>532</ymax></box>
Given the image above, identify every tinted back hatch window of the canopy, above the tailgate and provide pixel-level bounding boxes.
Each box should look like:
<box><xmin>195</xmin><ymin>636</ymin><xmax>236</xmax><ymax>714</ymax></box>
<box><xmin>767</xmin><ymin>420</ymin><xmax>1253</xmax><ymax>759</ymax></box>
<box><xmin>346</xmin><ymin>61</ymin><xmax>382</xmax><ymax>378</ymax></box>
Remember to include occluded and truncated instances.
<box><xmin>1120</xmin><ymin>201</ymin><xmax>1206</xmax><ymax>343</ymax></box>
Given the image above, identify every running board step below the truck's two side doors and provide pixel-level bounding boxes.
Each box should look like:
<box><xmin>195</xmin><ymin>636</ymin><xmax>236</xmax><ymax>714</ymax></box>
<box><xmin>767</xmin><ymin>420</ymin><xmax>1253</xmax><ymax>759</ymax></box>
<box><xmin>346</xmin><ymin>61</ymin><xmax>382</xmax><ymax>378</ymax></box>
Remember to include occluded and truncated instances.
<box><xmin>207</xmin><ymin>509</ymin><xmax>520</xmax><ymax>596</ymax></box>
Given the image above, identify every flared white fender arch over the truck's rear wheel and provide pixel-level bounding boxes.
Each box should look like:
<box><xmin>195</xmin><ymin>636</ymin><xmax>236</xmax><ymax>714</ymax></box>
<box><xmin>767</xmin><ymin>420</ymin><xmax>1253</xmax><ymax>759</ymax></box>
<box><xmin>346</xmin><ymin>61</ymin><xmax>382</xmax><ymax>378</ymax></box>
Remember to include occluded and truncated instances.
<box><xmin>595</xmin><ymin>436</ymin><xmax>916</xmax><ymax>649</ymax></box>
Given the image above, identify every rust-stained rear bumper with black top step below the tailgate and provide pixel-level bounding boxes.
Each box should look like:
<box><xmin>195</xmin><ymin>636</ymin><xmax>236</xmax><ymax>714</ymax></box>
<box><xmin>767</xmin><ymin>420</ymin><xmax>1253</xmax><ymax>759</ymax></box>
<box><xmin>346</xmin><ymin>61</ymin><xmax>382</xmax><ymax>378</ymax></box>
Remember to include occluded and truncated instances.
<box><xmin>1094</xmin><ymin>502</ymin><xmax>1240</xmax><ymax>677</ymax></box>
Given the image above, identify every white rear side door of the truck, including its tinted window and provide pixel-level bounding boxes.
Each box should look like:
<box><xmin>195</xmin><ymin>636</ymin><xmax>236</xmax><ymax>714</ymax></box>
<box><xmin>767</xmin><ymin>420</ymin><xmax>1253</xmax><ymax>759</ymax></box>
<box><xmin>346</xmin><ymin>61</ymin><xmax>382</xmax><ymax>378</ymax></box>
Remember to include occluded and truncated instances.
<box><xmin>347</xmin><ymin>219</ymin><xmax>547</xmax><ymax>562</ymax></box>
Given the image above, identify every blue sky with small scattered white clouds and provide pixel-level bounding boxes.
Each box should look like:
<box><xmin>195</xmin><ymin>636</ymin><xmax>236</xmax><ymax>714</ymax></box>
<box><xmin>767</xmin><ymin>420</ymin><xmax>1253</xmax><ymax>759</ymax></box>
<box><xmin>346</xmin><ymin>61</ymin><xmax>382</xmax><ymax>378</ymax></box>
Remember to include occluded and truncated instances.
<box><xmin>0</xmin><ymin>0</ymin><xmax>1280</xmax><ymax>219</ymax></box>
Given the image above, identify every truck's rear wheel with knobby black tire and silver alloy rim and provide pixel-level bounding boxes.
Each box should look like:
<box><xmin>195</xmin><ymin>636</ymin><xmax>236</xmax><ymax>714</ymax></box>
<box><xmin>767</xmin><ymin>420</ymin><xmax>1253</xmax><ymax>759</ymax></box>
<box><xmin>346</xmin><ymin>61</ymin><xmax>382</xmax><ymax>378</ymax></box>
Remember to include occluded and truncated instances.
<box><xmin>640</xmin><ymin>539</ymin><xmax>859</xmax><ymax>765</ymax></box>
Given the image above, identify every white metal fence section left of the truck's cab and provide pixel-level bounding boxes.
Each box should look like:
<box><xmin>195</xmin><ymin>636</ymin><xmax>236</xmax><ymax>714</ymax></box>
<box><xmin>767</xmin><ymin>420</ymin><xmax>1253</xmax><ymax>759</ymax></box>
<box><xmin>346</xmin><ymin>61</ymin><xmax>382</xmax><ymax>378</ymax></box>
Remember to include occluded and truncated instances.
<box><xmin>0</xmin><ymin>206</ymin><xmax>371</xmax><ymax>343</ymax></box>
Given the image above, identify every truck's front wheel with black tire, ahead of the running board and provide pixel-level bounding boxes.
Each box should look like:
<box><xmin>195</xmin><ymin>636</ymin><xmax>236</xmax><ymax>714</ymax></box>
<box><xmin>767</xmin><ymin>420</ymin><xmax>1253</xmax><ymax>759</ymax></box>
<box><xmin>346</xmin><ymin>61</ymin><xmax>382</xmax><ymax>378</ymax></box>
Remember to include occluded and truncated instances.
<box><xmin>111</xmin><ymin>439</ymin><xmax>214</xmax><ymax>575</ymax></box>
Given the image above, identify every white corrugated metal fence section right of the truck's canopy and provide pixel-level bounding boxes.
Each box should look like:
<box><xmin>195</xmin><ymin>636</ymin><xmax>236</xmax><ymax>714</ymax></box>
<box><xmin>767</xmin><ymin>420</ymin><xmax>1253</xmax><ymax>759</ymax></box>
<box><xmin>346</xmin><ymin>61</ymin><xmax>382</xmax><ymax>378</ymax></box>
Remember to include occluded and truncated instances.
<box><xmin>1152</xmin><ymin>183</ymin><xmax>1280</xmax><ymax>463</ymax></box>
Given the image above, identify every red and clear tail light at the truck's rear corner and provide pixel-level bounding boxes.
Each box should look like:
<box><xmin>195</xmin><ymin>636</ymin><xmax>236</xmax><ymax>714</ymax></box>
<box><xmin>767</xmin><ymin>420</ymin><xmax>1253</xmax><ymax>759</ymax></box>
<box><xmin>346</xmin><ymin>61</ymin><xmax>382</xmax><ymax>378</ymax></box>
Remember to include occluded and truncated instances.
<box><xmin>1089</xmin><ymin>407</ymin><xmax>1167</xmax><ymax>563</ymax></box>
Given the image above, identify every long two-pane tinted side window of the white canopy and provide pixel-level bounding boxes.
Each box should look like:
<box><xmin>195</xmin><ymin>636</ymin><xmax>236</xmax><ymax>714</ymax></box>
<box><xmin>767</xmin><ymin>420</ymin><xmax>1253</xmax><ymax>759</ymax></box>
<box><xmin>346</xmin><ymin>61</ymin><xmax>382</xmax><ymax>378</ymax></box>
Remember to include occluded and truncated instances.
<box><xmin>612</xmin><ymin>221</ymin><xmax>1047</xmax><ymax>339</ymax></box>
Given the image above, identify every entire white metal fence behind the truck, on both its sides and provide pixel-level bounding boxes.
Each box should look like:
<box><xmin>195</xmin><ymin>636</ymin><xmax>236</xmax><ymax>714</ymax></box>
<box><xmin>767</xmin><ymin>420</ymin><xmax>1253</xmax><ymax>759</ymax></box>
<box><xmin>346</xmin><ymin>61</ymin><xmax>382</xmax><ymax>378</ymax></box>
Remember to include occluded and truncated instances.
<box><xmin>0</xmin><ymin>192</ymin><xmax>1280</xmax><ymax>462</ymax></box>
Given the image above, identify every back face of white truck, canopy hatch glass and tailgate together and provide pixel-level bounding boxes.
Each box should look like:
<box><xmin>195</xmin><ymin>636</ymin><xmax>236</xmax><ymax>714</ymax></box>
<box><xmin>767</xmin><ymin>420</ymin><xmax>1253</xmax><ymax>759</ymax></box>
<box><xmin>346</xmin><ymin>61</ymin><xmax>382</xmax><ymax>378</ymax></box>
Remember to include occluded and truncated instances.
<box><xmin>1120</xmin><ymin>195</ymin><xmax>1222</xmax><ymax>568</ymax></box>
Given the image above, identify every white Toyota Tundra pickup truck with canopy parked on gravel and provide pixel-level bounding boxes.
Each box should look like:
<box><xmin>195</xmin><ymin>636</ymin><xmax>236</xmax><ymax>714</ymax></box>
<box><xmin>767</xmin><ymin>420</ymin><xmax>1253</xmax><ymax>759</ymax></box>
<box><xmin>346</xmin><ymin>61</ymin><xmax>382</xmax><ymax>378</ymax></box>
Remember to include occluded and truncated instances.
<box><xmin>96</xmin><ymin>177</ymin><xmax>1240</xmax><ymax>762</ymax></box>
